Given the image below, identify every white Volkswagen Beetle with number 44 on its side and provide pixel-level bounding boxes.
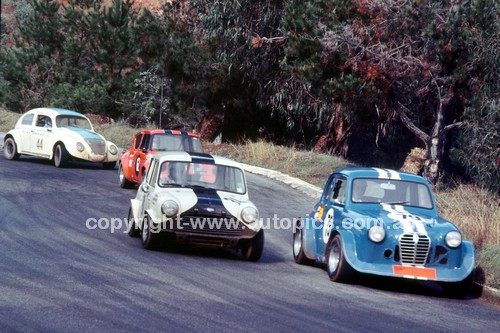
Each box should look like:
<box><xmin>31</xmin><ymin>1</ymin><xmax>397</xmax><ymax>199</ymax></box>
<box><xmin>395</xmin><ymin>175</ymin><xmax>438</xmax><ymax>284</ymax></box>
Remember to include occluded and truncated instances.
<box><xmin>4</xmin><ymin>108</ymin><xmax>119</xmax><ymax>169</ymax></box>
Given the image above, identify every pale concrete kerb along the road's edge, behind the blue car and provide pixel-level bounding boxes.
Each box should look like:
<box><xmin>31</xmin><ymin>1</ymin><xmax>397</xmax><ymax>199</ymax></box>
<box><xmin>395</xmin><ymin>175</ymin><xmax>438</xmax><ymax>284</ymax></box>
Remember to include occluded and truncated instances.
<box><xmin>240</xmin><ymin>163</ymin><xmax>500</xmax><ymax>305</ymax></box>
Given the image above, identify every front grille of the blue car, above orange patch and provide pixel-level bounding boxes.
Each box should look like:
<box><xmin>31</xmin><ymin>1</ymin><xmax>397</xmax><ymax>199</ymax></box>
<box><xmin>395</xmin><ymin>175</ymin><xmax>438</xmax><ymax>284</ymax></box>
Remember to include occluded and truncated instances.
<box><xmin>399</xmin><ymin>233</ymin><xmax>431</xmax><ymax>265</ymax></box>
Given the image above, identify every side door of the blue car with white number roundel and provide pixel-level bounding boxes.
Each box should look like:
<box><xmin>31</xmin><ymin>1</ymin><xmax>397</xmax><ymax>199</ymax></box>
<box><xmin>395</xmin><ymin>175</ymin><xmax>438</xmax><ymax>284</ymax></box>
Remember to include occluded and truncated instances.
<box><xmin>316</xmin><ymin>175</ymin><xmax>347</xmax><ymax>258</ymax></box>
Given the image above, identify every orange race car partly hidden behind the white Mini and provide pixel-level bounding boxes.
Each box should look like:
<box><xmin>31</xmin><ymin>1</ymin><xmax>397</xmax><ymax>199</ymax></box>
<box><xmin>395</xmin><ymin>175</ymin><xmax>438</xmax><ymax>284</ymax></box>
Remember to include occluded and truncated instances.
<box><xmin>118</xmin><ymin>129</ymin><xmax>203</xmax><ymax>188</ymax></box>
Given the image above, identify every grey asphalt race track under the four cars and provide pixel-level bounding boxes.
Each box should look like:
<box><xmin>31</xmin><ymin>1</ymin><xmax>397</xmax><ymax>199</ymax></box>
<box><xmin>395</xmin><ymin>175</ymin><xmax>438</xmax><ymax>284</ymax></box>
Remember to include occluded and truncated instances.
<box><xmin>0</xmin><ymin>154</ymin><xmax>500</xmax><ymax>332</ymax></box>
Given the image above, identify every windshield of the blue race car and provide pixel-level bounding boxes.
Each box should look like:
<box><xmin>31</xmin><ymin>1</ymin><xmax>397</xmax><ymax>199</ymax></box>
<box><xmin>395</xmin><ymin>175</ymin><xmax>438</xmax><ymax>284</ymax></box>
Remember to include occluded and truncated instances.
<box><xmin>351</xmin><ymin>178</ymin><xmax>433</xmax><ymax>209</ymax></box>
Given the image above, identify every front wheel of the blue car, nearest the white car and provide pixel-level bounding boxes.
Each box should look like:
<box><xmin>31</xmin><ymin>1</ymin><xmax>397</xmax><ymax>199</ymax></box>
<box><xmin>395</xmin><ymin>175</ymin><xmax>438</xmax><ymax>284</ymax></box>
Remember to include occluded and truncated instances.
<box><xmin>326</xmin><ymin>235</ymin><xmax>354</xmax><ymax>282</ymax></box>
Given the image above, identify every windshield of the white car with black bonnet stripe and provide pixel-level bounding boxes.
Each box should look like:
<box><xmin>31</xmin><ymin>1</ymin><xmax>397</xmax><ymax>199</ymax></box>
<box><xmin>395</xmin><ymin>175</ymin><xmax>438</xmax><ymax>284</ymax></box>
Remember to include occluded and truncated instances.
<box><xmin>158</xmin><ymin>161</ymin><xmax>246</xmax><ymax>194</ymax></box>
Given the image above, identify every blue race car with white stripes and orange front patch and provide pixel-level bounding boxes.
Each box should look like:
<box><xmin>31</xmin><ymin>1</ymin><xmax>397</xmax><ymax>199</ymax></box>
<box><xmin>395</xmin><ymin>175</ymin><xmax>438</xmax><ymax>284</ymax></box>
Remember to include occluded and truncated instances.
<box><xmin>293</xmin><ymin>168</ymin><xmax>475</xmax><ymax>293</ymax></box>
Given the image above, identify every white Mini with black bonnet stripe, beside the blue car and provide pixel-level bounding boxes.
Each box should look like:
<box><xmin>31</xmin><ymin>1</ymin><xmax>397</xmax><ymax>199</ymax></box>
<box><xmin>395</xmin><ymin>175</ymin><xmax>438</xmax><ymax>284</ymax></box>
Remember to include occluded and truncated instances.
<box><xmin>128</xmin><ymin>152</ymin><xmax>264</xmax><ymax>261</ymax></box>
